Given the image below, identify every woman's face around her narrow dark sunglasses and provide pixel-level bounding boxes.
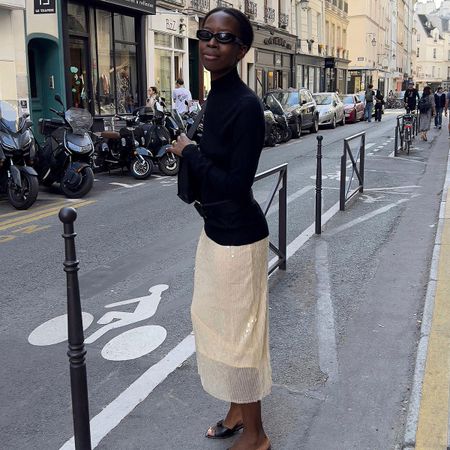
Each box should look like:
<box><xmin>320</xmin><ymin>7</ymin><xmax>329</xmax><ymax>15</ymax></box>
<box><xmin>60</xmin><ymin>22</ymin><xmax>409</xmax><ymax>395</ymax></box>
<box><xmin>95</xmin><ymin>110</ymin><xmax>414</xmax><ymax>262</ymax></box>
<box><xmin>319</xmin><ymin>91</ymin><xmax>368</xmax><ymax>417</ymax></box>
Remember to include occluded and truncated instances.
<box><xmin>199</xmin><ymin>11</ymin><xmax>247</xmax><ymax>80</ymax></box>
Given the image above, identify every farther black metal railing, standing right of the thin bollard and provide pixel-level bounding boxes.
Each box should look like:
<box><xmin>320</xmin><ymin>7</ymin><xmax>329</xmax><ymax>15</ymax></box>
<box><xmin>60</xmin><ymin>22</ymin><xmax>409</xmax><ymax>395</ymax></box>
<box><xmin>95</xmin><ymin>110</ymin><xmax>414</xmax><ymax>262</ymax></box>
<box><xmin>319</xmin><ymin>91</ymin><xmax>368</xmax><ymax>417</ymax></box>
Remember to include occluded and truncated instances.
<box><xmin>339</xmin><ymin>131</ymin><xmax>366</xmax><ymax>211</ymax></box>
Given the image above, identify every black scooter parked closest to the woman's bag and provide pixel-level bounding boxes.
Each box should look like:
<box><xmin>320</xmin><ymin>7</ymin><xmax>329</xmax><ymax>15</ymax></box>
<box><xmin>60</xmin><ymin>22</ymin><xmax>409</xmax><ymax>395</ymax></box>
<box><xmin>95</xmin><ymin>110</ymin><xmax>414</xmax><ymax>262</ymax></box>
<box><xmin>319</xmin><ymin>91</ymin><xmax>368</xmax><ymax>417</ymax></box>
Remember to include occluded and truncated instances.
<box><xmin>136</xmin><ymin>100</ymin><xmax>182</xmax><ymax>175</ymax></box>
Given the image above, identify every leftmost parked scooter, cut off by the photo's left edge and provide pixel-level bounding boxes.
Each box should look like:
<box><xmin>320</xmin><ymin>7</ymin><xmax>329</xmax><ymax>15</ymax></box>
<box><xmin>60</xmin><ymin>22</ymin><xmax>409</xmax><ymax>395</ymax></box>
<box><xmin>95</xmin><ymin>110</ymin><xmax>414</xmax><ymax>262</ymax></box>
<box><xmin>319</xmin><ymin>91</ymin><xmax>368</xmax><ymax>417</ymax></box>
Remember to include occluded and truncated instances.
<box><xmin>0</xmin><ymin>100</ymin><xmax>39</xmax><ymax>209</ymax></box>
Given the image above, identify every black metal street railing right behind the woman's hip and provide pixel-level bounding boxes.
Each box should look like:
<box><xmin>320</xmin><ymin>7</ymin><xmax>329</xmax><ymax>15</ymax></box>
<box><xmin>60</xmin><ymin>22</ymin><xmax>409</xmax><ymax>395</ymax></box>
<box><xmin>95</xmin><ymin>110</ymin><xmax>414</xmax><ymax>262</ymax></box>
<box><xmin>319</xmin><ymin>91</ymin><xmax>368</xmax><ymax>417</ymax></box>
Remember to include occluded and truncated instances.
<box><xmin>255</xmin><ymin>163</ymin><xmax>288</xmax><ymax>275</ymax></box>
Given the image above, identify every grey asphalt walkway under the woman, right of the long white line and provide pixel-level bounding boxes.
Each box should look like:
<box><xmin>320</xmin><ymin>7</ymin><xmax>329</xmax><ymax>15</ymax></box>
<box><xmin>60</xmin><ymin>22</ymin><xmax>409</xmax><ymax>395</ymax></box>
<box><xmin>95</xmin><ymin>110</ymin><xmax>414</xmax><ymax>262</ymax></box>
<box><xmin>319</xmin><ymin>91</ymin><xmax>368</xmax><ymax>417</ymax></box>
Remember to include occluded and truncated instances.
<box><xmin>93</xmin><ymin>124</ymin><xmax>450</xmax><ymax>450</ymax></box>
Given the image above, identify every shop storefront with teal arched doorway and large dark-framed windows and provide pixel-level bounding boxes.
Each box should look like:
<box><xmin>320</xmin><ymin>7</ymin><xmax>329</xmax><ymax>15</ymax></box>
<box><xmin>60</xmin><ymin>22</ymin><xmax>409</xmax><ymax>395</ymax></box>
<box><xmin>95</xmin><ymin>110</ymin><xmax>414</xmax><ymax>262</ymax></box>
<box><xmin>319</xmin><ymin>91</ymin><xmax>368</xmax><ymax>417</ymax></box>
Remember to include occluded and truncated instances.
<box><xmin>27</xmin><ymin>0</ymin><xmax>155</xmax><ymax>125</ymax></box>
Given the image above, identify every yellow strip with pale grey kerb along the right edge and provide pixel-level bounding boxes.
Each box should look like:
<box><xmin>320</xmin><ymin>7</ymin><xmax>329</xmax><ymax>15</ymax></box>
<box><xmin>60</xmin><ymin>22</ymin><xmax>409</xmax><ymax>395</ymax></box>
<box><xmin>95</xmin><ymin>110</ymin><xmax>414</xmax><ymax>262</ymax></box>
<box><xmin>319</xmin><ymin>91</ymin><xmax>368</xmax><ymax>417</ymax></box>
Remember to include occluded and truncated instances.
<box><xmin>405</xmin><ymin>131</ymin><xmax>450</xmax><ymax>450</ymax></box>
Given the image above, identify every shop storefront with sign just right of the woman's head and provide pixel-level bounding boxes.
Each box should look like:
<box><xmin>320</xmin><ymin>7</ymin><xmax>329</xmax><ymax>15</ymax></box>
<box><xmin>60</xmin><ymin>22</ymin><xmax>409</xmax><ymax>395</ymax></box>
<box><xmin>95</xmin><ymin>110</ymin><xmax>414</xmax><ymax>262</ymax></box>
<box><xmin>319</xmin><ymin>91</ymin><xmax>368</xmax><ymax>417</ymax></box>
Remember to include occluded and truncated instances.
<box><xmin>254</xmin><ymin>27</ymin><xmax>296</xmax><ymax>97</ymax></box>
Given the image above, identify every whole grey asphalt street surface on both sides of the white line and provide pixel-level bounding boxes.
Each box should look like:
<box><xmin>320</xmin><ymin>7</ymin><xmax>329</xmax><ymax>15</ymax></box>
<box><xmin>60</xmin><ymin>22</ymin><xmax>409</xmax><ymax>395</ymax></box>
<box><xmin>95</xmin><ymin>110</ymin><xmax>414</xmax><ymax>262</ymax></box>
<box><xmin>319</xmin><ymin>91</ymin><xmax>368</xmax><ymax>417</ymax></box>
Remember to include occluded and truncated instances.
<box><xmin>0</xmin><ymin>111</ymin><xmax>448</xmax><ymax>450</ymax></box>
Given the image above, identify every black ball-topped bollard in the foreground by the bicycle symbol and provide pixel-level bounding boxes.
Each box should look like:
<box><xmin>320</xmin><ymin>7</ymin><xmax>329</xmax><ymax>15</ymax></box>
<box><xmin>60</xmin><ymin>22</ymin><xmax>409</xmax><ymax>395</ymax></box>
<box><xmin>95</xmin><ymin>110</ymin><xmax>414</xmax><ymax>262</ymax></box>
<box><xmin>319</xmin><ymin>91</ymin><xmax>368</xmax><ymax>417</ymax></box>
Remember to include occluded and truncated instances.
<box><xmin>59</xmin><ymin>208</ymin><xmax>91</xmax><ymax>450</ymax></box>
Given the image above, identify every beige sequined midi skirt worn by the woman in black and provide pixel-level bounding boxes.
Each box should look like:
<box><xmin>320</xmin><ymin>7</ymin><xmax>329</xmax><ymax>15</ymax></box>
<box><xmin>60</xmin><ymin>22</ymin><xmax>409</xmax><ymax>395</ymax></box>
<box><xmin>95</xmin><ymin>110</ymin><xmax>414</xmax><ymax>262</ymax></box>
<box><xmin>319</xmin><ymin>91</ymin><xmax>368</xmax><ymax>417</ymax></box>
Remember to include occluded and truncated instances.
<box><xmin>191</xmin><ymin>231</ymin><xmax>272</xmax><ymax>403</ymax></box>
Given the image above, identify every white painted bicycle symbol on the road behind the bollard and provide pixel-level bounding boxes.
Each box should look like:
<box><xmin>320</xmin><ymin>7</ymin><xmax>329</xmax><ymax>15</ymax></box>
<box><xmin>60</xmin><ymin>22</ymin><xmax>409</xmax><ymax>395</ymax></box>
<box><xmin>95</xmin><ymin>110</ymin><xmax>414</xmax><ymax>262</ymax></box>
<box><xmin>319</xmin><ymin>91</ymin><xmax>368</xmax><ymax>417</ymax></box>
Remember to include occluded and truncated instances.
<box><xmin>28</xmin><ymin>284</ymin><xmax>169</xmax><ymax>361</ymax></box>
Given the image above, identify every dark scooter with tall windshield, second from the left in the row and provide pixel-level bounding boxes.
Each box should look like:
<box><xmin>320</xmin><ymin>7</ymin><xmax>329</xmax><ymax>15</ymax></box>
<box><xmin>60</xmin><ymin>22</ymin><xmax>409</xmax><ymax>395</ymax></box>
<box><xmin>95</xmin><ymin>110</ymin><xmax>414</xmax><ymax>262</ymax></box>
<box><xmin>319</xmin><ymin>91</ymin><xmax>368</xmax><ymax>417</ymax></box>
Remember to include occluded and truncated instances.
<box><xmin>37</xmin><ymin>95</ymin><xmax>94</xmax><ymax>198</ymax></box>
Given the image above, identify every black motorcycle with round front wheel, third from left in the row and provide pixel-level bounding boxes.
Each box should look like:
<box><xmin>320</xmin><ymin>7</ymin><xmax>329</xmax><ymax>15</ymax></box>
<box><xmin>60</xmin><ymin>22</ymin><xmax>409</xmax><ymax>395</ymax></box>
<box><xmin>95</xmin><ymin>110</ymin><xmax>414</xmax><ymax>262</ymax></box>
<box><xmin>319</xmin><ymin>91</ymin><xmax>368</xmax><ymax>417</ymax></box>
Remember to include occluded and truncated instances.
<box><xmin>94</xmin><ymin>115</ymin><xmax>153</xmax><ymax>180</ymax></box>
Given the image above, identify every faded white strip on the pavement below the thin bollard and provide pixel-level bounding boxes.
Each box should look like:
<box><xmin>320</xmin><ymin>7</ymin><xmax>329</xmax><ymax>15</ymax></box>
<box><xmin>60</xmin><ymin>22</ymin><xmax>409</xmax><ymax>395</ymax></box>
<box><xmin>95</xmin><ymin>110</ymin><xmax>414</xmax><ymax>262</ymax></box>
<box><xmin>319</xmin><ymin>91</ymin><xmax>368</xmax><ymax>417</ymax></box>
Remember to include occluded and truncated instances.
<box><xmin>315</xmin><ymin>240</ymin><xmax>339</xmax><ymax>382</ymax></box>
